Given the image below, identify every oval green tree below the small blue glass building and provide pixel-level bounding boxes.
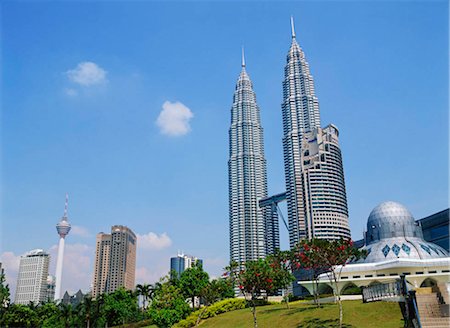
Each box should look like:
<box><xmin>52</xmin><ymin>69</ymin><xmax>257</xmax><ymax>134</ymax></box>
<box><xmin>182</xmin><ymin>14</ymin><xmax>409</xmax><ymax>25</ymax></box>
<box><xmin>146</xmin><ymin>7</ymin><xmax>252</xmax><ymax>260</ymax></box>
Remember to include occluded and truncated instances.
<box><xmin>179</xmin><ymin>262</ymin><xmax>209</xmax><ymax>309</ymax></box>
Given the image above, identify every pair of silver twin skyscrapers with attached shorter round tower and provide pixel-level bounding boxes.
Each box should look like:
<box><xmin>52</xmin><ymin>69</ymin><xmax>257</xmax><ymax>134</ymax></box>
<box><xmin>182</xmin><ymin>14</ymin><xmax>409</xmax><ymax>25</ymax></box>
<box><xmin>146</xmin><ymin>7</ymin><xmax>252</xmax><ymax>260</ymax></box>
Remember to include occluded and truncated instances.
<box><xmin>228</xmin><ymin>19</ymin><xmax>350</xmax><ymax>263</ymax></box>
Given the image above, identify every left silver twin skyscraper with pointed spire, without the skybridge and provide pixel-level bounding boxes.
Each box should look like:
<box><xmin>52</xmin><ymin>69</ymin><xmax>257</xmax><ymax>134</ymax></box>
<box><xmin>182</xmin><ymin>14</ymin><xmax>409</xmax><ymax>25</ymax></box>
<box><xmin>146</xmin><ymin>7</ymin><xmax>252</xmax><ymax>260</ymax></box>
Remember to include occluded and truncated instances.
<box><xmin>228</xmin><ymin>54</ymin><xmax>273</xmax><ymax>263</ymax></box>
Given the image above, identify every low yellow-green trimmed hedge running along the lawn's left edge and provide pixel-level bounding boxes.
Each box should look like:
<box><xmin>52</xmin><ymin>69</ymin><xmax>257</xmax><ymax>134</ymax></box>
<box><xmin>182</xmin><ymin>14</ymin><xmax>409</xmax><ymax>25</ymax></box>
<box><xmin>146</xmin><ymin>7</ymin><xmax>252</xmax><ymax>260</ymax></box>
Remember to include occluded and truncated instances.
<box><xmin>175</xmin><ymin>298</ymin><xmax>248</xmax><ymax>328</ymax></box>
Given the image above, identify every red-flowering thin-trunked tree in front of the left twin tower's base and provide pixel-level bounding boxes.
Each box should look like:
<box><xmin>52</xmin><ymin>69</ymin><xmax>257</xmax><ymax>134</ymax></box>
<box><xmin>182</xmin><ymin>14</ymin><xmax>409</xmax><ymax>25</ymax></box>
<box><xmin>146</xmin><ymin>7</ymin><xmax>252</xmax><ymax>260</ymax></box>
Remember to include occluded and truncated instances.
<box><xmin>230</xmin><ymin>258</ymin><xmax>293</xmax><ymax>328</ymax></box>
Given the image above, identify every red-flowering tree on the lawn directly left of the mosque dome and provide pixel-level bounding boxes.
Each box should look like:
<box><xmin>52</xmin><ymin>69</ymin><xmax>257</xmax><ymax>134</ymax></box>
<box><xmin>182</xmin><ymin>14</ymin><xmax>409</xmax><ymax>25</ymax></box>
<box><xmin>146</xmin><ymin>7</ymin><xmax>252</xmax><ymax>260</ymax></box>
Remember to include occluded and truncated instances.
<box><xmin>293</xmin><ymin>239</ymin><xmax>367</xmax><ymax>327</ymax></box>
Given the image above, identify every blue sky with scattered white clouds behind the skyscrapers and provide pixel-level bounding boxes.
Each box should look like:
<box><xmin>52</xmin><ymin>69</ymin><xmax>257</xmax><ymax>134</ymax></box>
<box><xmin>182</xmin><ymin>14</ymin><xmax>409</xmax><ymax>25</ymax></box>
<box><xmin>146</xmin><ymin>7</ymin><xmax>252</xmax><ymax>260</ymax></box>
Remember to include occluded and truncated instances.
<box><xmin>0</xmin><ymin>1</ymin><xmax>449</xmax><ymax>290</ymax></box>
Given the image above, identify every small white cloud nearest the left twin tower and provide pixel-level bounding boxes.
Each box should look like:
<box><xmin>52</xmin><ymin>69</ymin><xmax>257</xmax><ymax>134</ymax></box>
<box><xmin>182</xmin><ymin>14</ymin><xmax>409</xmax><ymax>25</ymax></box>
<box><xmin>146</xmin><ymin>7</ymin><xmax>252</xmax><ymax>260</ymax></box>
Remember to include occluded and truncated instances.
<box><xmin>156</xmin><ymin>101</ymin><xmax>194</xmax><ymax>137</ymax></box>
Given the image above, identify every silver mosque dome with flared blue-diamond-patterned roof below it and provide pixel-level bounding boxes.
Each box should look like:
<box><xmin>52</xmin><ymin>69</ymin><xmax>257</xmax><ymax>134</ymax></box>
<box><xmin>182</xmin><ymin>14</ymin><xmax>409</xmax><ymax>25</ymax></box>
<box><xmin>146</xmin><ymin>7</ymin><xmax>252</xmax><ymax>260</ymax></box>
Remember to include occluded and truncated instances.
<box><xmin>363</xmin><ymin>201</ymin><xmax>449</xmax><ymax>263</ymax></box>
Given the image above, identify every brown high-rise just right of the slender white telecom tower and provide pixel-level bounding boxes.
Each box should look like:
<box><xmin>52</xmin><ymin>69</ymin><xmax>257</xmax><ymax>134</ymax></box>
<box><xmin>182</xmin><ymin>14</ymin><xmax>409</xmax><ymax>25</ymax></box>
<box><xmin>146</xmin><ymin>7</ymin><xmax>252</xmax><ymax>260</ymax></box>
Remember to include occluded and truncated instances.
<box><xmin>92</xmin><ymin>225</ymin><xmax>137</xmax><ymax>297</ymax></box>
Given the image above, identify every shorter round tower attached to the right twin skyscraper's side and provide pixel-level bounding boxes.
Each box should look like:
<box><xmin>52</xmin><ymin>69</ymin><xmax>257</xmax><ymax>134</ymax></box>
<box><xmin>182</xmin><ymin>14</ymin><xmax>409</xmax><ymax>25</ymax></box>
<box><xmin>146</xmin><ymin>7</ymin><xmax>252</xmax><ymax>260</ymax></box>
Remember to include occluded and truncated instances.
<box><xmin>301</xmin><ymin>124</ymin><xmax>351</xmax><ymax>239</ymax></box>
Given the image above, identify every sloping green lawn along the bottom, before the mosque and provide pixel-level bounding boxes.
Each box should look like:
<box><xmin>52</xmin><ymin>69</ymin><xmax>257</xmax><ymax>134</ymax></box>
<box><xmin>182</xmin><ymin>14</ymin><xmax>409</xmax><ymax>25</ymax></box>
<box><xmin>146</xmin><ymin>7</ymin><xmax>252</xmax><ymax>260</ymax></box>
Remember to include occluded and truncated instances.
<box><xmin>195</xmin><ymin>301</ymin><xmax>403</xmax><ymax>328</ymax></box>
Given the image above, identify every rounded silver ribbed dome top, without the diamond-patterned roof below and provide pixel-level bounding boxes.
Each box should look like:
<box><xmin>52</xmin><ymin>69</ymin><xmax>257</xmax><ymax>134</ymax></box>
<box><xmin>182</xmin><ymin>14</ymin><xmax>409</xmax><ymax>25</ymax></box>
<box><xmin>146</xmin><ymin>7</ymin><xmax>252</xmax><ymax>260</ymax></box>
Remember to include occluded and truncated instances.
<box><xmin>366</xmin><ymin>201</ymin><xmax>423</xmax><ymax>245</ymax></box>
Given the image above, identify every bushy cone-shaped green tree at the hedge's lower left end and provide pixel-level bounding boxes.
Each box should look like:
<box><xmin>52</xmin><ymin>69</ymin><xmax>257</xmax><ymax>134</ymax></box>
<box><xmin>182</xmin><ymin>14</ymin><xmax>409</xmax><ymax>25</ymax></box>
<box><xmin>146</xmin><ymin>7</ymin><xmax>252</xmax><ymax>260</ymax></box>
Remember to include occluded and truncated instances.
<box><xmin>148</xmin><ymin>278</ymin><xmax>190</xmax><ymax>327</ymax></box>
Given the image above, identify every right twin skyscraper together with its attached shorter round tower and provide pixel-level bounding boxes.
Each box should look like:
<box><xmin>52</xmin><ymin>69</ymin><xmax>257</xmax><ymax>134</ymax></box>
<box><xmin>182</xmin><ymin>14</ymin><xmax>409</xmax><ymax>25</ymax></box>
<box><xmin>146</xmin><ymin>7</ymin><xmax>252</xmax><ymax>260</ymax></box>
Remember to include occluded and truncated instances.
<box><xmin>282</xmin><ymin>19</ymin><xmax>350</xmax><ymax>247</ymax></box>
